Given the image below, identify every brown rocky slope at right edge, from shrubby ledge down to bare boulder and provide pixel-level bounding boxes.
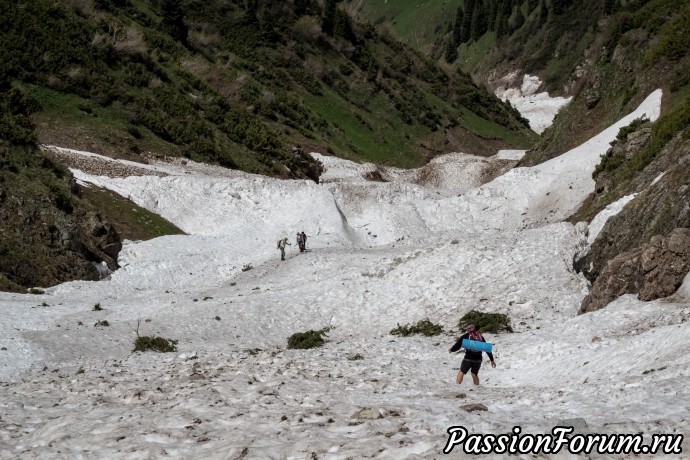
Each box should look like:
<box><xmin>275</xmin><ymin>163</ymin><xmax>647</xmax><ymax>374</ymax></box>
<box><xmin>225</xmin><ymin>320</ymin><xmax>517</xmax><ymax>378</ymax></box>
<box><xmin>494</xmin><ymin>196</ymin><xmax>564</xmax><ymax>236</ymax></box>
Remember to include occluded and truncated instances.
<box><xmin>575</xmin><ymin>127</ymin><xmax>690</xmax><ymax>312</ymax></box>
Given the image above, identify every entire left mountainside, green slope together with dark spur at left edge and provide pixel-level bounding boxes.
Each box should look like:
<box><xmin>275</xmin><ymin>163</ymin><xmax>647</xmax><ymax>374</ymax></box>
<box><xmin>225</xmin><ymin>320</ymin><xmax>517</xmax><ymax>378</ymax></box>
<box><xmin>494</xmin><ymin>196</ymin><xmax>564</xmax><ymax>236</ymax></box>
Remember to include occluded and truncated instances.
<box><xmin>0</xmin><ymin>0</ymin><xmax>537</xmax><ymax>289</ymax></box>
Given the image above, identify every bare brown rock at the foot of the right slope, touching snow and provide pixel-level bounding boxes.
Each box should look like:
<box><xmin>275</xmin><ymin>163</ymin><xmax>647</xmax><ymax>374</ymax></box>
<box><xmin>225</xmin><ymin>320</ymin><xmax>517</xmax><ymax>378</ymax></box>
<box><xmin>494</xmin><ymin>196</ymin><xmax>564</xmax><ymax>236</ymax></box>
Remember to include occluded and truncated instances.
<box><xmin>580</xmin><ymin>228</ymin><xmax>690</xmax><ymax>313</ymax></box>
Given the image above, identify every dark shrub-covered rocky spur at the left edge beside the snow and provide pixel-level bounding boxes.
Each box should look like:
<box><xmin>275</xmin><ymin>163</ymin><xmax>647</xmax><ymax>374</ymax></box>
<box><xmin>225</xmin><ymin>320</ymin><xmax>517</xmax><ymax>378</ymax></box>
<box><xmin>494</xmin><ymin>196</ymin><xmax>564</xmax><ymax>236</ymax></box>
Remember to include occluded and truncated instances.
<box><xmin>0</xmin><ymin>149</ymin><xmax>122</xmax><ymax>291</ymax></box>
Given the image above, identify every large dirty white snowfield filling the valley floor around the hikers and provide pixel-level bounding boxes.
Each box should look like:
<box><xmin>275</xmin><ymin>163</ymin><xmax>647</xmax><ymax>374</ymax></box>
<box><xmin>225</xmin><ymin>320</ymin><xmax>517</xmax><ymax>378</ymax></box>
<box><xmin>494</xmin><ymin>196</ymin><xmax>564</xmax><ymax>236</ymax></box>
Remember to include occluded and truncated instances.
<box><xmin>0</xmin><ymin>91</ymin><xmax>690</xmax><ymax>459</ymax></box>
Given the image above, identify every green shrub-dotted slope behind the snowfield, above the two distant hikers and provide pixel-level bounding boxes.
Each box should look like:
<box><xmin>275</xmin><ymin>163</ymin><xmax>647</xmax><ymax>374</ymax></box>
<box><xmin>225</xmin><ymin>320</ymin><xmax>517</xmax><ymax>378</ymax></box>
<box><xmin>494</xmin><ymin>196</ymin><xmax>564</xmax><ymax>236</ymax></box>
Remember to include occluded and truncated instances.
<box><xmin>0</xmin><ymin>0</ymin><xmax>534</xmax><ymax>177</ymax></box>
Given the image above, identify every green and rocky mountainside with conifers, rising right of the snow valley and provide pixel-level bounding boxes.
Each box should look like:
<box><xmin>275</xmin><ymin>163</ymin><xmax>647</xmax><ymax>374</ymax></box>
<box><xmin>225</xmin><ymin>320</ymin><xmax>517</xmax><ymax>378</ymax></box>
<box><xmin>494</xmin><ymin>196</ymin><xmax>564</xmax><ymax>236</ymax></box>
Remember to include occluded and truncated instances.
<box><xmin>348</xmin><ymin>0</ymin><xmax>690</xmax><ymax>308</ymax></box>
